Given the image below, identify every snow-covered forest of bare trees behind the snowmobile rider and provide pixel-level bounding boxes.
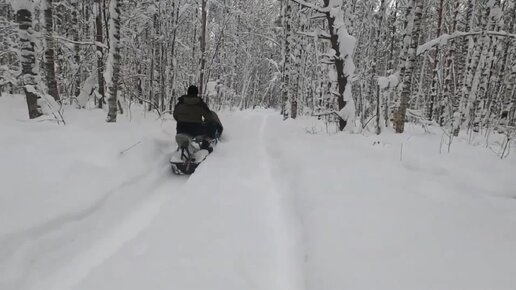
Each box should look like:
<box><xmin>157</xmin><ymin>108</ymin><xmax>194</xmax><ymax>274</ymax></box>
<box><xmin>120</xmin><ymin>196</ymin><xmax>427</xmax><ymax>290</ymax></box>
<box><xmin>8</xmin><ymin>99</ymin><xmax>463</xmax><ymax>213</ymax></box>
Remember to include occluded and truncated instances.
<box><xmin>0</xmin><ymin>0</ymin><xmax>516</xmax><ymax>136</ymax></box>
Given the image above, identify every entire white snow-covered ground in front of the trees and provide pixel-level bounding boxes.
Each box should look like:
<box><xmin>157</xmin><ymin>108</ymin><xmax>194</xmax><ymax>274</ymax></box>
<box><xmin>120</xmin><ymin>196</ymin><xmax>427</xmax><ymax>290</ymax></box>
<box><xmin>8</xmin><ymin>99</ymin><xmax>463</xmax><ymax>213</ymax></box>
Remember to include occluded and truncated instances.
<box><xmin>0</xmin><ymin>96</ymin><xmax>516</xmax><ymax>290</ymax></box>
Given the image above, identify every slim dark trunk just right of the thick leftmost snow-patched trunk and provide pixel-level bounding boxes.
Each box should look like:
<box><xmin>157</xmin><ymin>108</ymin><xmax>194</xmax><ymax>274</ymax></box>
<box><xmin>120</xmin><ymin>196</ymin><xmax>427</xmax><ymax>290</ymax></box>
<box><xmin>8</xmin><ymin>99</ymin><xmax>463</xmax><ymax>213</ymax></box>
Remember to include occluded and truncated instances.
<box><xmin>44</xmin><ymin>0</ymin><xmax>61</xmax><ymax>102</ymax></box>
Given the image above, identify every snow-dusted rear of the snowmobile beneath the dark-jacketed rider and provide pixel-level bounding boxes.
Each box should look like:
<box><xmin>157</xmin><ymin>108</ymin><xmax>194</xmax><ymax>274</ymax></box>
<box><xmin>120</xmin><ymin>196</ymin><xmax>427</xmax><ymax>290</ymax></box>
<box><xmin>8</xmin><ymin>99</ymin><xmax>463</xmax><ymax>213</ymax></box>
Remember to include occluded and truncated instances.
<box><xmin>170</xmin><ymin>134</ymin><xmax>217</xmax><ymax>175</ymax></box>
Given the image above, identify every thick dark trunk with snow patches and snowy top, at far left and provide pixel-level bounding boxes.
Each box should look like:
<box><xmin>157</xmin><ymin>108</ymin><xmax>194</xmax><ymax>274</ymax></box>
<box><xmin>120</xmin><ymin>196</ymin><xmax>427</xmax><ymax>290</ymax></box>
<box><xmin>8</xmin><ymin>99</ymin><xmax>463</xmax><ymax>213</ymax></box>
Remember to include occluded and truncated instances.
<box><xmin>16</xmin><ymin>9</ymin><xmax>43</xmax><ymax>119</ymax></box>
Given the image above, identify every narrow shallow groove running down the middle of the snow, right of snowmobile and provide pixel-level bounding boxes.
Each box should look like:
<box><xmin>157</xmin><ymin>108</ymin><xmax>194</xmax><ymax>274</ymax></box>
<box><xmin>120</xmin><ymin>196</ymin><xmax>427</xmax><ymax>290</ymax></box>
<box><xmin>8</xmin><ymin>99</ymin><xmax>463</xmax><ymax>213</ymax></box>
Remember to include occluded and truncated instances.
<box><xmin>259</xmin><ymin>115</ymin><xmax>306</xmax><ymax>290</ymax></box>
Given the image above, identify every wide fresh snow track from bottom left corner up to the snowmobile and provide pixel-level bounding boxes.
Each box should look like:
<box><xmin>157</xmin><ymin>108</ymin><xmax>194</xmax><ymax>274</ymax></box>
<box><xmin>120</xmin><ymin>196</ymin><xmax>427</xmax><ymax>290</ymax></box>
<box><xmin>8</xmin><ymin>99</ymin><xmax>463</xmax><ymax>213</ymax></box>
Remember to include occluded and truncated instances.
<box><xmin>0</xmin><ymin>163</ymin><xmax>185</xmax><ymax>290</ymax></box>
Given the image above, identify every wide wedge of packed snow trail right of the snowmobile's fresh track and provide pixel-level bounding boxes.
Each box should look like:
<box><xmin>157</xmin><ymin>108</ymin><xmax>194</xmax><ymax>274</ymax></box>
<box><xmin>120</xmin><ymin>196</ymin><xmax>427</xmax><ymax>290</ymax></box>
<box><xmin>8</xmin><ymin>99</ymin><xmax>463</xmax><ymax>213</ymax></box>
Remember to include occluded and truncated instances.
<box><xmin>68</xmin><ymin>112</ymin><xmax>304</xmax><ymax>290</ymax></box>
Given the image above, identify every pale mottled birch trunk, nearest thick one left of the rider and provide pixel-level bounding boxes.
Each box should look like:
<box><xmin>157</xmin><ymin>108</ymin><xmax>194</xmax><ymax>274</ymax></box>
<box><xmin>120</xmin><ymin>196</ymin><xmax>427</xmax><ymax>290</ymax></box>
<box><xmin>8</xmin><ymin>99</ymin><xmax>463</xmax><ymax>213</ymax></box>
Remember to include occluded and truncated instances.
<box><xmin>106</xmin><ymin>0</ymin><xmax>123</xmax><ymax>122</ymax></box>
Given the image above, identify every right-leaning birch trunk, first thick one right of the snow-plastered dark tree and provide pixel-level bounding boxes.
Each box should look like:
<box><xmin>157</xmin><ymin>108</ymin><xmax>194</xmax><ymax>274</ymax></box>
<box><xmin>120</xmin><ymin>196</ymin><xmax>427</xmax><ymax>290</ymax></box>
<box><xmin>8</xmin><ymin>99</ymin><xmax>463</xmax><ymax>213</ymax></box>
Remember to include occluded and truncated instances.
<box><xmin>394</xmin><ymin>0</ymin><xmax>423</xmax><ymax>133</ymax></box>
